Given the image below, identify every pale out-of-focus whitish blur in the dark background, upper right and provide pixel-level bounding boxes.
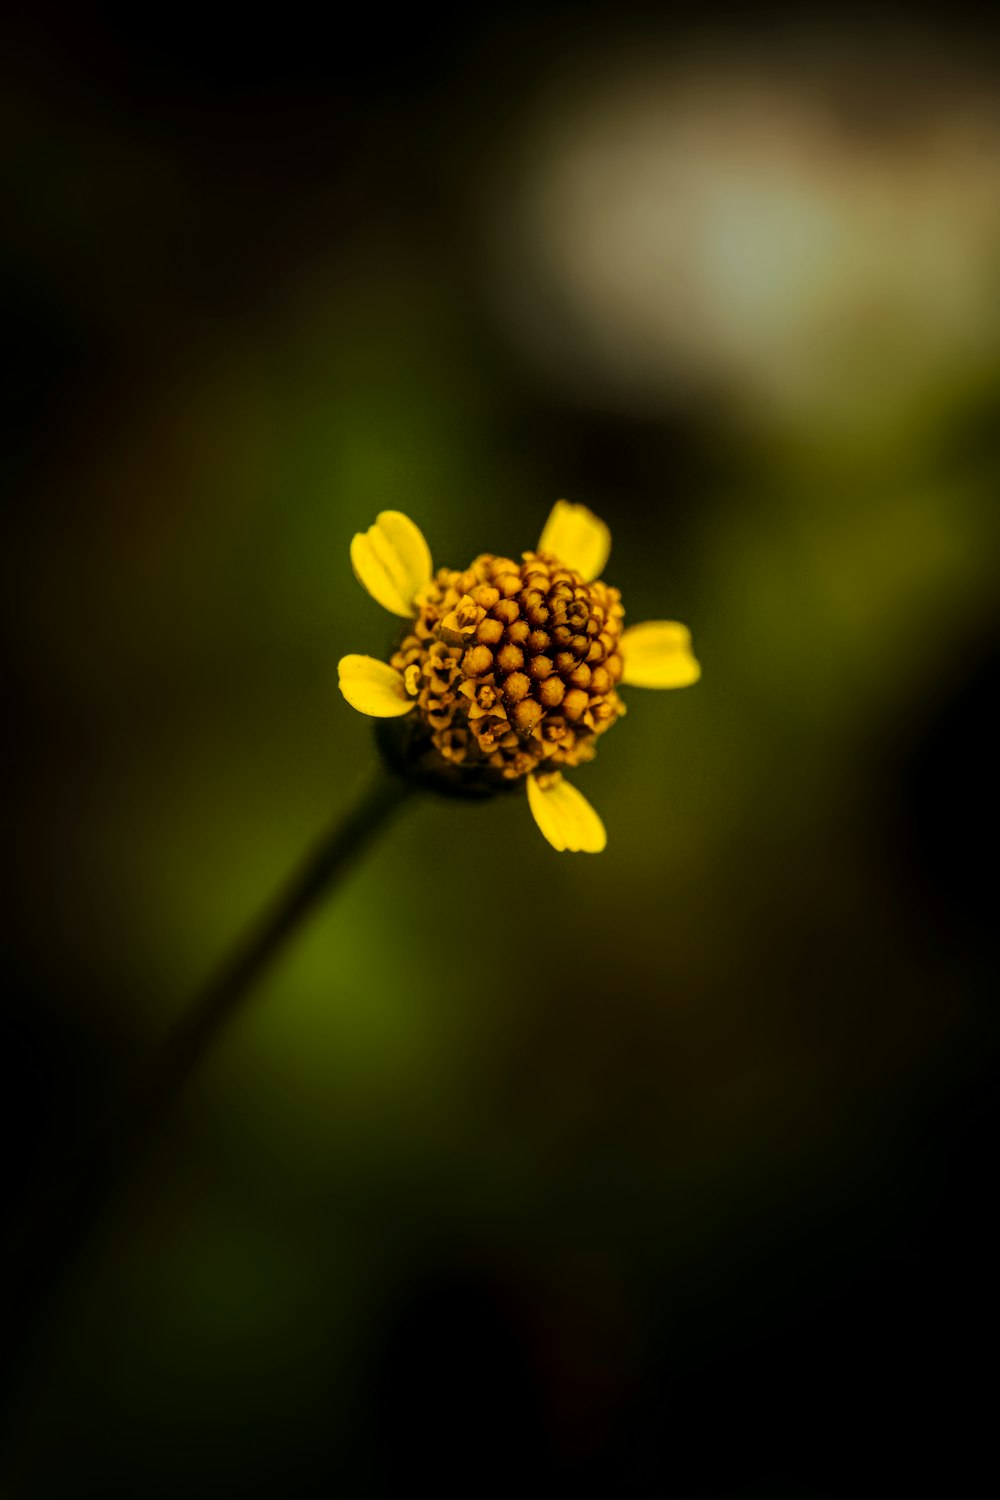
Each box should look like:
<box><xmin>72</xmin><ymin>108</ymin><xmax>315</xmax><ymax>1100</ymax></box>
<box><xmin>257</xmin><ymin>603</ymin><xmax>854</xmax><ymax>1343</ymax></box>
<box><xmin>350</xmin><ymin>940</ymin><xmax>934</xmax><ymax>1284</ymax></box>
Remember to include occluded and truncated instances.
<box><xmin>490</xmin><ymin>50</ymin><xmax>1000</xmax><ymax>420</ymax></box>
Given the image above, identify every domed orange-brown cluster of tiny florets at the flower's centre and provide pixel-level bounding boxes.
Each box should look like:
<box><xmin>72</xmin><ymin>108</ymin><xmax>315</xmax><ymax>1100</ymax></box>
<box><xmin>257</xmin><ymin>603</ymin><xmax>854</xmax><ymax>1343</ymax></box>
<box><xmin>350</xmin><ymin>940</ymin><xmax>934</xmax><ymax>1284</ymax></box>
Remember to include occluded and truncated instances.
<box><xmin>391</xmin><ymin>552</ymin><xmax>625</xmax><ymax>780</ymax></box>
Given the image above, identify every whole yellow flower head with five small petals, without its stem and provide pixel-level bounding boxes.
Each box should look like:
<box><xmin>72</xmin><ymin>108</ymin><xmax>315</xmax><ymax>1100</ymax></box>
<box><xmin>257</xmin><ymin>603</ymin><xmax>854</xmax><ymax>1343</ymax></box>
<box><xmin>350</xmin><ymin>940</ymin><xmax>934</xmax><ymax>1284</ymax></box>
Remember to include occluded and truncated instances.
<box><xmin>339</xmin><ymin>500</ymin><xmax>700</xmax><ymax>854</ymax></box>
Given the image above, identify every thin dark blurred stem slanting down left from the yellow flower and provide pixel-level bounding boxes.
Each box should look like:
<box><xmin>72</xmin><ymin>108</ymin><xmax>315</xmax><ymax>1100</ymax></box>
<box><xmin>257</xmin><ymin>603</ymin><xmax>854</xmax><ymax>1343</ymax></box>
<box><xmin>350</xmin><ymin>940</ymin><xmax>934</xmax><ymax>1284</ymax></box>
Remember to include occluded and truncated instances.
<box><xmin>0</xmin><ymin>767</ymin><xmax>411</xmax><ymax>1421</ymax></box>
